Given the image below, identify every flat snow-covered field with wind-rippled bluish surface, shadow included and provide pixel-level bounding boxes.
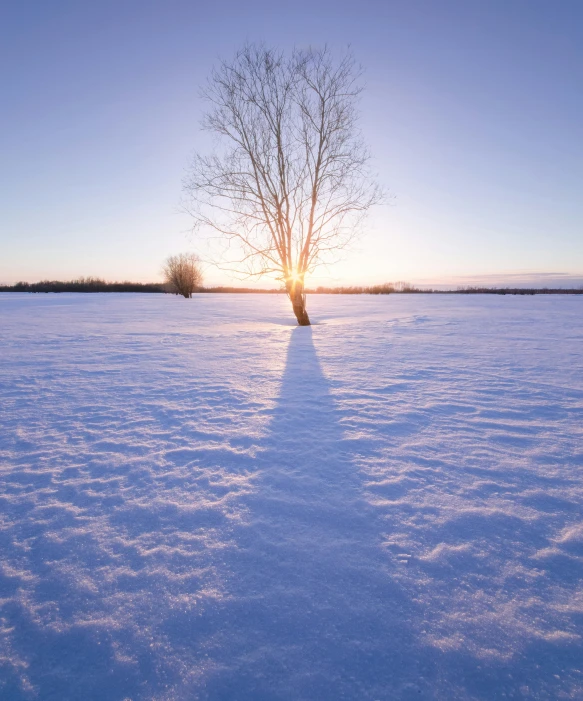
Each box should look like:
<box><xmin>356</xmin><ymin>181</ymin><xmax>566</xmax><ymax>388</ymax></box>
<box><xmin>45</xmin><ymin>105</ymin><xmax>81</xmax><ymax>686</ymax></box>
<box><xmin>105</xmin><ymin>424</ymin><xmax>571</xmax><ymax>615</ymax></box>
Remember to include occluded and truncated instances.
<box><xmin>0</xmin><ymin>294</ymin><xmax>583</xmax><ymax>701</ymax></box>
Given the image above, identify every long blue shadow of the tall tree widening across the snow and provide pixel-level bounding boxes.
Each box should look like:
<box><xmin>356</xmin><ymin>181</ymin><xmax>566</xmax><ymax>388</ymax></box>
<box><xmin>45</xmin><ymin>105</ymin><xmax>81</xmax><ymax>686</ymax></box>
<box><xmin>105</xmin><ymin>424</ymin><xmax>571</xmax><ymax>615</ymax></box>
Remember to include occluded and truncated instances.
<box><xmin>198</xmin><ymin>328</ymin><xmax>431</xmax><ymax>701</ymax></box>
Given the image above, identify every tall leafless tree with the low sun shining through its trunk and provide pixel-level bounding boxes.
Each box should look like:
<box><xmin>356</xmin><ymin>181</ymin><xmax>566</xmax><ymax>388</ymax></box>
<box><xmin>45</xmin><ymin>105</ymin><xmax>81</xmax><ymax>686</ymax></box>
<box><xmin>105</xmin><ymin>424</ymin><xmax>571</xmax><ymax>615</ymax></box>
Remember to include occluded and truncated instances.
<box><xmin>184</xmin><ymin>44</ymin><xmax>381</xmax><ymax>326</ymax></box>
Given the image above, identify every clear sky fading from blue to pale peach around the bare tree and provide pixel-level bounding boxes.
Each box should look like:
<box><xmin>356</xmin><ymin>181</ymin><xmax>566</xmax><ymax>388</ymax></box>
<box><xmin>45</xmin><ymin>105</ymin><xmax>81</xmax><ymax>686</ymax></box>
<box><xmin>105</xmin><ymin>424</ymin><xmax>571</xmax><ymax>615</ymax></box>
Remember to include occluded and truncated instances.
<box><xmin>0</xmin><ymin>0</ymin><xmax>583</xmax><ymax>284</ymax></box>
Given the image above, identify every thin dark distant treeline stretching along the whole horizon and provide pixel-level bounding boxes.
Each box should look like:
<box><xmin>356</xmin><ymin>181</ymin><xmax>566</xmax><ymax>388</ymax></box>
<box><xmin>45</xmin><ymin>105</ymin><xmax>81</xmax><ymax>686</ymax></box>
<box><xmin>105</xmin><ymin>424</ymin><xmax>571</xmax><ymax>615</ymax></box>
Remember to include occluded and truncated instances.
<box><xmin>0</xmin><ymin>277</ymin><xmax>583</xmax><ymax>295</ymax></box>
